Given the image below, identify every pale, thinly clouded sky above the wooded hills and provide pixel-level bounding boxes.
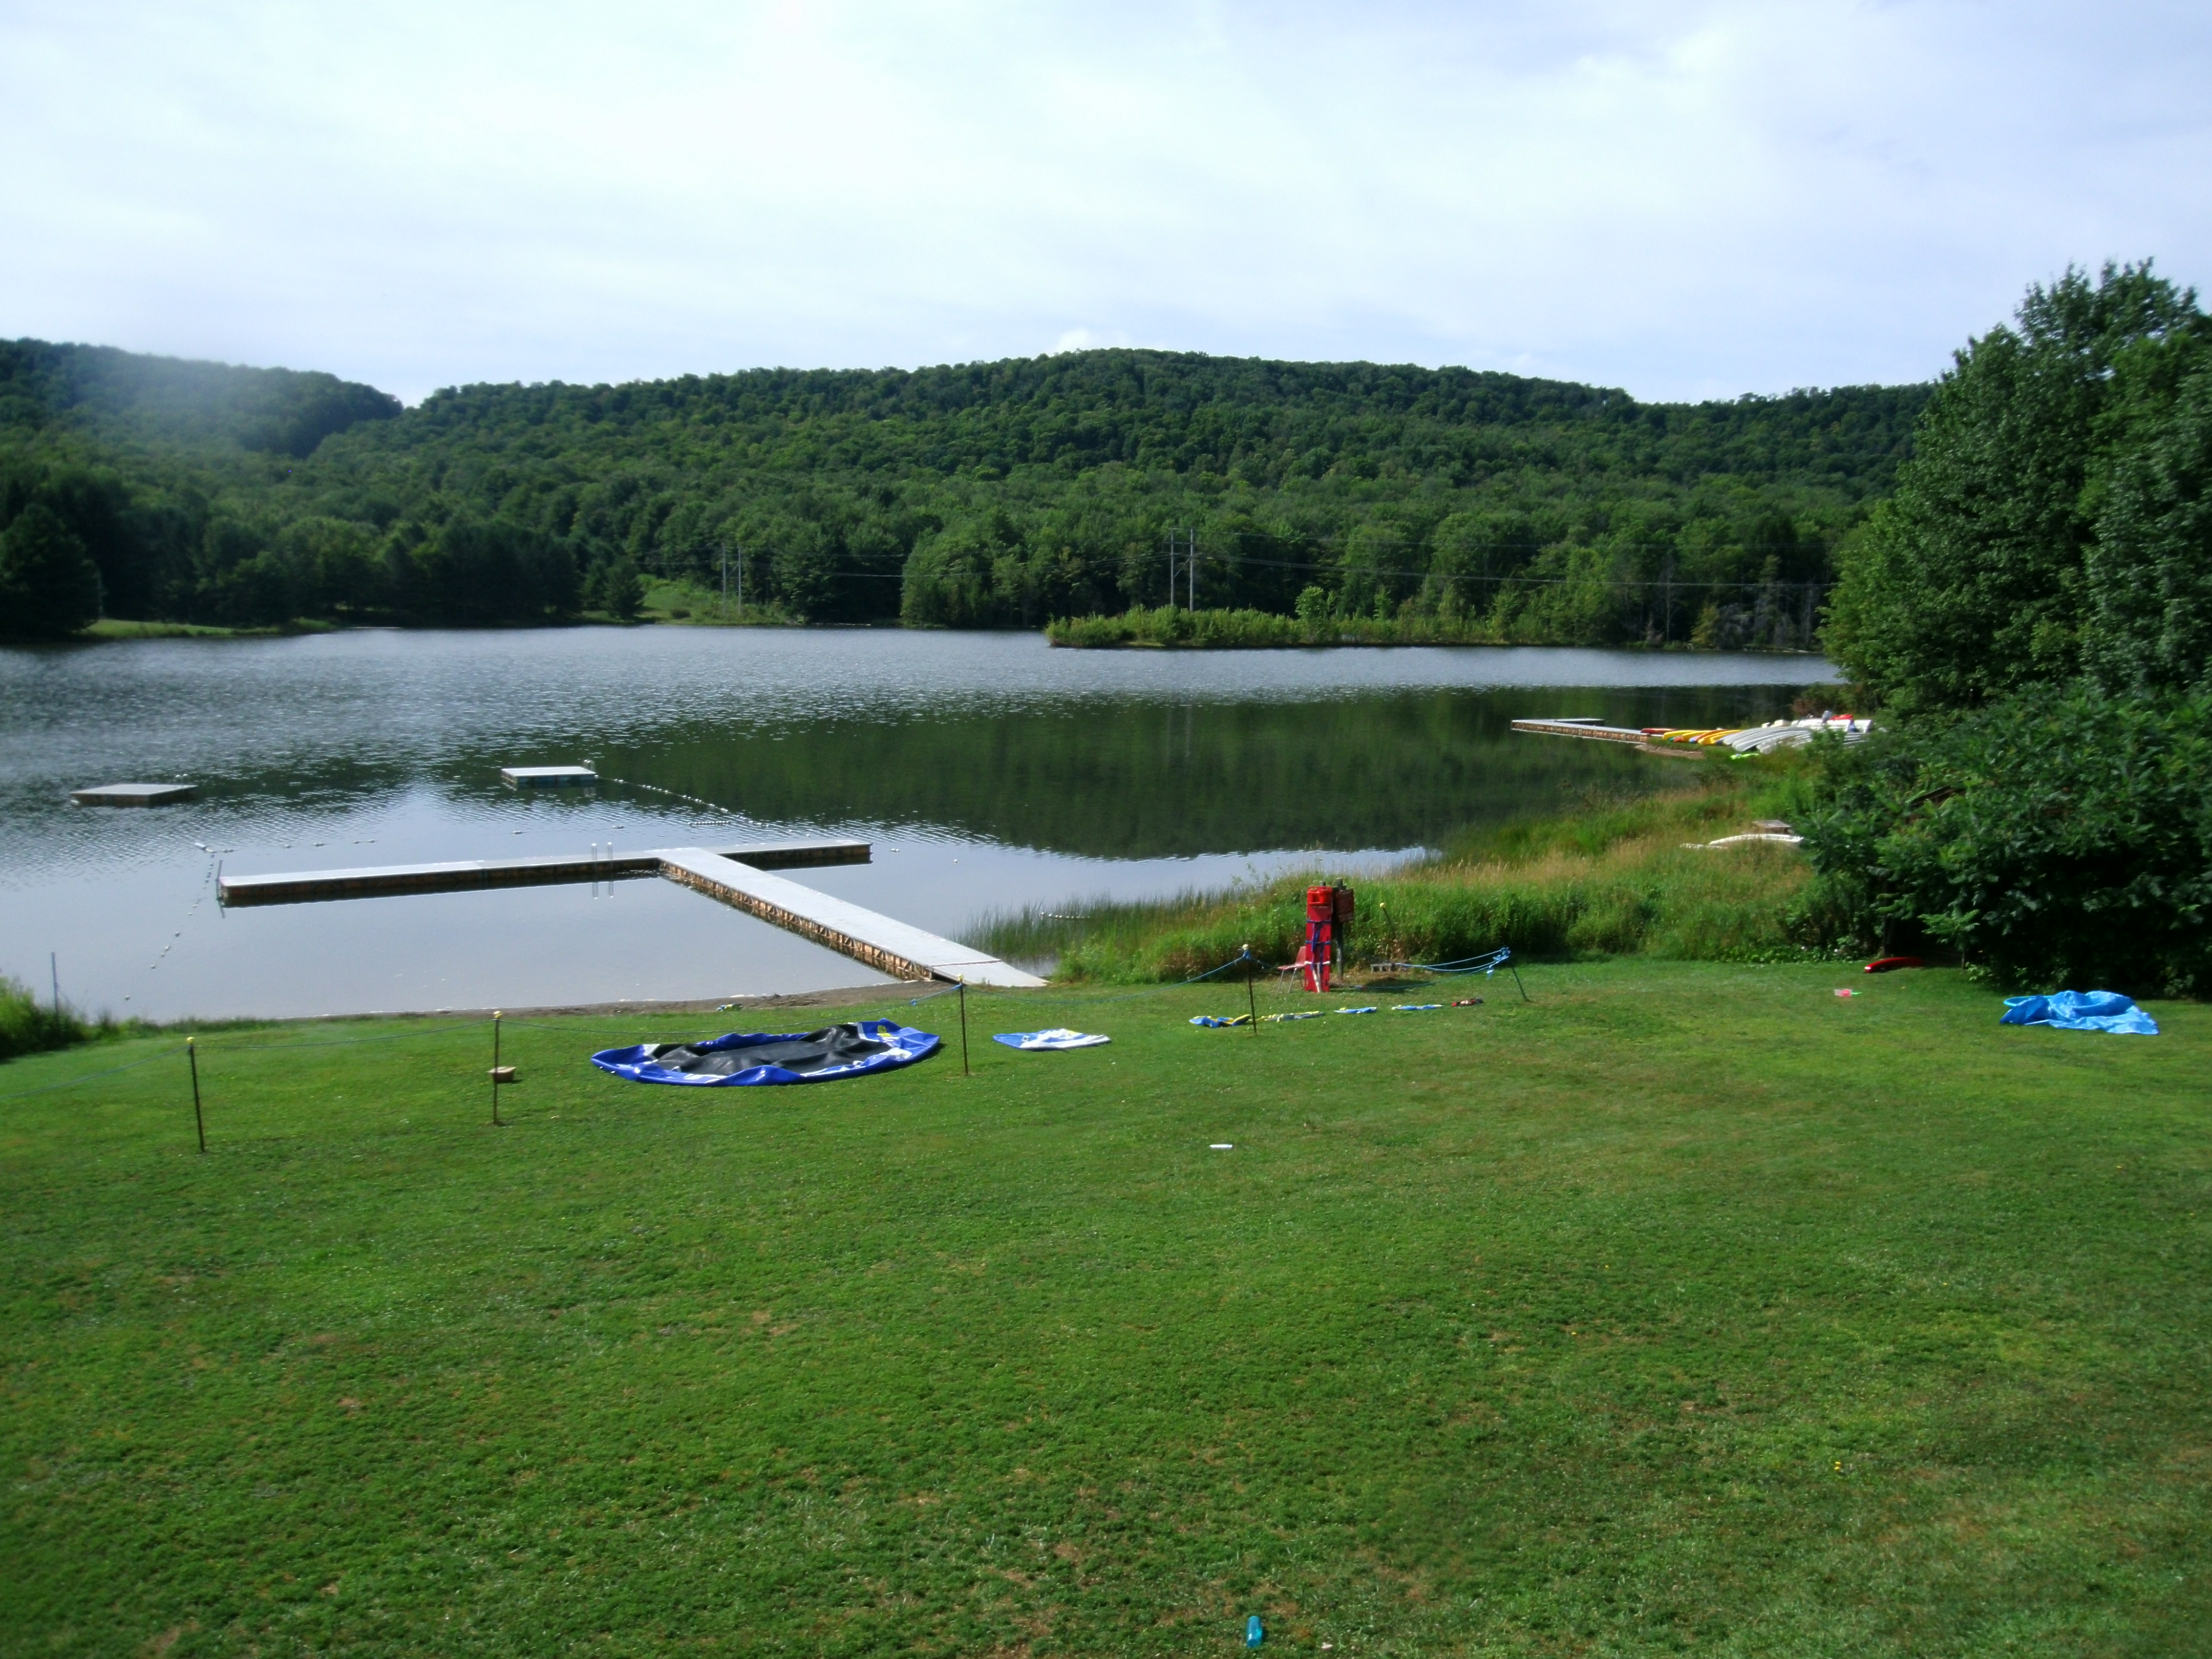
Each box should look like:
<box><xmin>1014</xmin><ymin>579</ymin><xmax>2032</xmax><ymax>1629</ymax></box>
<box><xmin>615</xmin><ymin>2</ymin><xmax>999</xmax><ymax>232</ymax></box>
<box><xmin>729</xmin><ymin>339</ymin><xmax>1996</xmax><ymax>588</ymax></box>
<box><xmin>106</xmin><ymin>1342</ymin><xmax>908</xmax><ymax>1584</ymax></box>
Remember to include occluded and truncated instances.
<box><xmin>0</xmin><ymin>0</ymin><xmax>2212</xmax><ymax>402</ymax></box>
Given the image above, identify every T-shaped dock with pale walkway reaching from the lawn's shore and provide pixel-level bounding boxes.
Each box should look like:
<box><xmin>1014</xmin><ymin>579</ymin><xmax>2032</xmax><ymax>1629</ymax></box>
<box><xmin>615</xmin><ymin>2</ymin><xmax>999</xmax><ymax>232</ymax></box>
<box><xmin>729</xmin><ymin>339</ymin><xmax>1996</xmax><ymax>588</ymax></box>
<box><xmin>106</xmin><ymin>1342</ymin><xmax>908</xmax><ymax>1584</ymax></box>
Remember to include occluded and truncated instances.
<box><xmin>215</xmin><ymin>841</ymin><xmax>1044</xmax><ymax>991</ymax></box>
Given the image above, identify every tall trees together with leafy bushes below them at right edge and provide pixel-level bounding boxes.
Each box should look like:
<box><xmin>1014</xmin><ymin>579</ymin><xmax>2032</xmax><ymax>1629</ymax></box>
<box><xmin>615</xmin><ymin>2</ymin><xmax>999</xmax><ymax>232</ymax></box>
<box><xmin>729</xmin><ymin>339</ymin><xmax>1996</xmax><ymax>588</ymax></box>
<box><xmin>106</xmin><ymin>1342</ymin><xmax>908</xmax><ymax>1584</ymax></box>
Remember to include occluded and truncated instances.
<box><xmin>1807</xmin><ymin>265</ymin><xmax>2212</xmax><ymax>995</ymax></box>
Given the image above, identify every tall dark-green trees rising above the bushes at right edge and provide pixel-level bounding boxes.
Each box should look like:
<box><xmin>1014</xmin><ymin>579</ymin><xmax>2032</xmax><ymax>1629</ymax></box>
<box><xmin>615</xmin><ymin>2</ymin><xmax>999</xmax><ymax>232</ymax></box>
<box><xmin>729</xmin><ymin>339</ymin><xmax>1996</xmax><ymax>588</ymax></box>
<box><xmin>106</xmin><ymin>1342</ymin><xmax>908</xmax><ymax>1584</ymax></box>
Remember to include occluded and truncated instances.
<box><xmin>1827</xmin><ymin>265</ymin><xmax>2212</xmax><ymax>712</ymax></box>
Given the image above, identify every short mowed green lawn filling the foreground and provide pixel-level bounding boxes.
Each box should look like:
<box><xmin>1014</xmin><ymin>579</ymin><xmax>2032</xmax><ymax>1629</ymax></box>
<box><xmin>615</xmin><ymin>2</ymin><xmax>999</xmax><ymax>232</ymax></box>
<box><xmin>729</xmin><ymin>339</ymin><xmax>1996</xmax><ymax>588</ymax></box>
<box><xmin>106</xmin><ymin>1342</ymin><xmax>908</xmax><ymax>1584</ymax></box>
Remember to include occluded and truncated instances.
<box><xmin>0</xmin><ymin>962</ymin><xmax>2212</xmax><ymax>1657</ymax></box>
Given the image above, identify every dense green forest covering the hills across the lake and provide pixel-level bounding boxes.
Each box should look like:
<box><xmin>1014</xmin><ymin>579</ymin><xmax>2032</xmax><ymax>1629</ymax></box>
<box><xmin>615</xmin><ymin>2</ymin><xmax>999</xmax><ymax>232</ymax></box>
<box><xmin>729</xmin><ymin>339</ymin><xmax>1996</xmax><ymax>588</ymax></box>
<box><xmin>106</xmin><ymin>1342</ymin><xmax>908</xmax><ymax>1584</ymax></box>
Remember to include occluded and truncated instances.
<box><xmin>0</xmin><ymin>341</ymin><xmax>1927</xmax><ymax>646</ymax></box>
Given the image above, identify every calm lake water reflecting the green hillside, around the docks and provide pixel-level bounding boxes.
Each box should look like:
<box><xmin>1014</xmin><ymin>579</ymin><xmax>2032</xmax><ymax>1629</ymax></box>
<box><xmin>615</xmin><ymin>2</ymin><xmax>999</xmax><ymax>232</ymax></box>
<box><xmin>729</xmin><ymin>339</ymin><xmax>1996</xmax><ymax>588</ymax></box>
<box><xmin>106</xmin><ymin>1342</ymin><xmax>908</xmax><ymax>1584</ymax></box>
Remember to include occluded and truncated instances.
<box><xmin>0</xmin><ymin>628</ymin><xmax>1830</xmax><ymax>1017</ymax></box>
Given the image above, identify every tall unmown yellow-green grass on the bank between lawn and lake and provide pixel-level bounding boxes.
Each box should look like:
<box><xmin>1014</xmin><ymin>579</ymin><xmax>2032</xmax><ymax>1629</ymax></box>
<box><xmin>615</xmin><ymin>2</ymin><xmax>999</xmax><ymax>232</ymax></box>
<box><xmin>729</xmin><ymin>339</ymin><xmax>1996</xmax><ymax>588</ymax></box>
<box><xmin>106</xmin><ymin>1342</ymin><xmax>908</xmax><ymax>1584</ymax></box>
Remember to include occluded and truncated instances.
<box><xmin>975</xmin><ymin>756</ymin><xmax>1820</xmax><ymax>984</ymax></box>
